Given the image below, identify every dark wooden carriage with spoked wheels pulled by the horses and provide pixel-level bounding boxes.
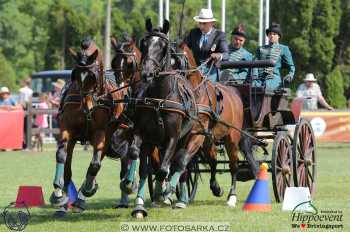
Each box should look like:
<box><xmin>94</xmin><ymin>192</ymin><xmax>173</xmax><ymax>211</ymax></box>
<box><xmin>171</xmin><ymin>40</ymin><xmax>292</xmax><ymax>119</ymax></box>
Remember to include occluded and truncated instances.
<box><xmin>148</xmin><ymin>61</ymin><xmax>317</xmax><ymax>202</ymax></box>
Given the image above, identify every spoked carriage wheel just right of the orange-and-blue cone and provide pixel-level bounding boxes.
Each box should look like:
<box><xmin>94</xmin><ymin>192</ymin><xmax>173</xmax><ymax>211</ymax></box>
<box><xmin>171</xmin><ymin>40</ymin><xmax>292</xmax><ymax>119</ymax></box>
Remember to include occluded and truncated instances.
<box><xmin>271</xmin><ymin>133</ymin><xmax>293</xmax><ymax>202</ymax></box>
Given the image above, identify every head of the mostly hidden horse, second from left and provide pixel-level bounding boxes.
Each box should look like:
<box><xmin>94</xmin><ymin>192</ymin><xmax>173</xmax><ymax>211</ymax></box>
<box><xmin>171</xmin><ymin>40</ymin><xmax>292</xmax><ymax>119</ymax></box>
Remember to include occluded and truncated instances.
<box><xmin>111</xmin><ymin>34</ymin><xmax>141</xmax><ymax>84</ymax></box>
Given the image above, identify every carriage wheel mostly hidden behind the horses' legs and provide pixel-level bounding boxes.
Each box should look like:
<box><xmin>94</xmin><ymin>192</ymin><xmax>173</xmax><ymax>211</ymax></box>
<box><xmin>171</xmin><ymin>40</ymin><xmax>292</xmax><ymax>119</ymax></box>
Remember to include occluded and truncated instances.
<box><xmin>176</xmin><ymin>156</ymin><xmax>199</xmax><ymax>202</ymax></box>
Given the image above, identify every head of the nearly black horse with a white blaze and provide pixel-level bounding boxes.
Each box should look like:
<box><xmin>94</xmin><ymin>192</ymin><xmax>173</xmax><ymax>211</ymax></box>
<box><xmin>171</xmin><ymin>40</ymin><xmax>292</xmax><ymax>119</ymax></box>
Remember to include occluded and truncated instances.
<box><xmin>140</xmin><ymin>19</ymin><xmax>171</xmax><ymax>82</ymax></box>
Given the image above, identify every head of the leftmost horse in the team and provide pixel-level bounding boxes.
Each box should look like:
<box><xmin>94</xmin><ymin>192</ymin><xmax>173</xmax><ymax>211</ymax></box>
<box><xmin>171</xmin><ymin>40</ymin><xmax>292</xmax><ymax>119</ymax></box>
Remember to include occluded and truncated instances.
<box><xmin>69</xmin><ymin>38</ymin><xmax>103</xmax><ymax>109</ymax></box>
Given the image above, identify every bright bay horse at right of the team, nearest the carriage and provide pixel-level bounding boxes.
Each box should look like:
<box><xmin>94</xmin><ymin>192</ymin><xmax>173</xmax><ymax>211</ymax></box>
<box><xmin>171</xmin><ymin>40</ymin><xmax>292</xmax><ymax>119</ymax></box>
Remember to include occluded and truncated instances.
<box><xmin>164</xmin><ymin>42</ymin><xmax>249</xmax><ymax>208</ymax></box>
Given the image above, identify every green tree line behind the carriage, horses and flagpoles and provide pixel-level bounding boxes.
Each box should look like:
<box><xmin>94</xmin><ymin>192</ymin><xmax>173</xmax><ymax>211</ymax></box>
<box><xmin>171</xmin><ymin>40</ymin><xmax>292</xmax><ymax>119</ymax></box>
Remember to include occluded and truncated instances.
<box><xmin>0</xmin><ymin>0</ymin><xmax>350</xmax><ymax>108</ymax></box>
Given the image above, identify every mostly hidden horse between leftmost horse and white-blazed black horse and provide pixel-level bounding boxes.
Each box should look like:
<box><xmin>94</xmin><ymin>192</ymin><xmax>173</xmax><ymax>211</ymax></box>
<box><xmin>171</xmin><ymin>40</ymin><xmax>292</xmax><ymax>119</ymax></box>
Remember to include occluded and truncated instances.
<box><xmin>111</xmin><ymin>34</ymin><xmax>141</xmax><ymax>208</ymax></box>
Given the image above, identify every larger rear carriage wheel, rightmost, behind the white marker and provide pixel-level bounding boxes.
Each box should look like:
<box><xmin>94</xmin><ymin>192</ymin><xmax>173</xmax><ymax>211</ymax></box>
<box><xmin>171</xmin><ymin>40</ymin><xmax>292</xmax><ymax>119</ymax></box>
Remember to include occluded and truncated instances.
<box><xmin>292</xmin><ymin>118</ymin><xmax>316</xmax><ymax>195</ymax></box>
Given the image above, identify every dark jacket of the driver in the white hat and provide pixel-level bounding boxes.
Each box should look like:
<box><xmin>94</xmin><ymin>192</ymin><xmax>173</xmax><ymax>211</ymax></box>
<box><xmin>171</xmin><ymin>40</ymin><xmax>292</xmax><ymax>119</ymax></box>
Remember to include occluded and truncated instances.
<box><xmin>185</xmin><ymin>28</ymin><xmax>228</xmax><ymax>65</ymax></box>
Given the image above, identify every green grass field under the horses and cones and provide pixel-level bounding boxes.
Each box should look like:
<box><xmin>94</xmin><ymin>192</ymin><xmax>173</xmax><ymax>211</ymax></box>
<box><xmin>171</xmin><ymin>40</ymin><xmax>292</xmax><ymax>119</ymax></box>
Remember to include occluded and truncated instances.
<box><xmin>0</xmin><ymin>144</ymin><xmax>350</xmax><ymax>232</ymax></box>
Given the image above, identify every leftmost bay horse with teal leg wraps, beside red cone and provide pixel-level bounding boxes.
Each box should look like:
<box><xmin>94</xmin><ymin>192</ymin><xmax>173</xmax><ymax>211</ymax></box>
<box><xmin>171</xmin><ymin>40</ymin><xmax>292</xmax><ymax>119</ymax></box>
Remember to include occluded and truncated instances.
<box><xmin>50</xmin><ymin>39</ymin><xmax>123</xmax><ymax>216</ymax></box>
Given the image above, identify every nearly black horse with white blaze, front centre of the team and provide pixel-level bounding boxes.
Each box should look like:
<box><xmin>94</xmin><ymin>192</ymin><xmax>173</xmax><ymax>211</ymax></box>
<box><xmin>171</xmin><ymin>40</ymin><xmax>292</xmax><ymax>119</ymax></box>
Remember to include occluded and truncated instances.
<box><xmin>124</xmin><ymin>20</ymin><xmax>202</xmax><ymax>217</ymax></box>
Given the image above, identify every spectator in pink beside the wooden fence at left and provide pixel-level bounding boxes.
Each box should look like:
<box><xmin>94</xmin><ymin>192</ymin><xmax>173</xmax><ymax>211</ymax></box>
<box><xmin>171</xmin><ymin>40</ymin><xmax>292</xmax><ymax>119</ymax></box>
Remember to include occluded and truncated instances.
<box><xmin>33</xmin><ymin>94</ymin><xmax>49</xmax><ymax>151</ymax></box>
